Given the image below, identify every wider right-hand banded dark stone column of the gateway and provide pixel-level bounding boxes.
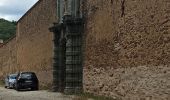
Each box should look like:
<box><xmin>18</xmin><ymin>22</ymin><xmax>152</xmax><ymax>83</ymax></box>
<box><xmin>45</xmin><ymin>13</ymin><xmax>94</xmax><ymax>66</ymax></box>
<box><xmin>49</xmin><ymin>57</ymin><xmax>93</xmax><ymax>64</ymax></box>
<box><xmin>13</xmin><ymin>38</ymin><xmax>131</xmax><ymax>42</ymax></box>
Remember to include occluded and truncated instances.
<box><xmin>63</xmin><ymin>16</ymin><xmax>83</xmax><ymax>94</ymax></box>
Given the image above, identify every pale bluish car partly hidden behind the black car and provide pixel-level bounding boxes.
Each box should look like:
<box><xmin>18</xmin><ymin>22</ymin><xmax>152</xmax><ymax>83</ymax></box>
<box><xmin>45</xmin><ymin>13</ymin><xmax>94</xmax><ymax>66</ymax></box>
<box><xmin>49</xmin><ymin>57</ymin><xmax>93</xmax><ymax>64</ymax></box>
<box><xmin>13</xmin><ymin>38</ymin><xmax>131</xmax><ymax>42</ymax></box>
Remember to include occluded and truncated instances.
<box><xmin>5</xmin><ymin>74</ymin><xmax>17</xmax><ymax>88</ymax></box>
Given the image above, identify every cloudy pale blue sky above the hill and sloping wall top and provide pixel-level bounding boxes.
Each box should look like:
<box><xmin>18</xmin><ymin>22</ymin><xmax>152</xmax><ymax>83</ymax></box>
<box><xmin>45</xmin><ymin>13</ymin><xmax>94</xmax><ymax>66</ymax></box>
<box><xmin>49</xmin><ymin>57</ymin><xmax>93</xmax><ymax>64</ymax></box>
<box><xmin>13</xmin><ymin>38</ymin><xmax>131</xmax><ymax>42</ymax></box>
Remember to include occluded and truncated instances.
<box><xmin>0</xmin><ymin>0</ymin><xmax>38</xmax><ymax>21</ymax></box>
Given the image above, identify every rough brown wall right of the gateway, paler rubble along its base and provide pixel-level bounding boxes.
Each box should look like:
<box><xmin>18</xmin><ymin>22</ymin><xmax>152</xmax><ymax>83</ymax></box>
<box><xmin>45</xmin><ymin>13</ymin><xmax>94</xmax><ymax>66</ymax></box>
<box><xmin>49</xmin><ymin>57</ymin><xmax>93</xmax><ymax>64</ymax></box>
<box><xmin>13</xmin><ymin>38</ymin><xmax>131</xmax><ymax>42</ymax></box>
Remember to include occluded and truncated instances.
<box><xmin>83</xmin><ymin>0</ymin><xmax>170</xmax><ymax>100</ymax></box>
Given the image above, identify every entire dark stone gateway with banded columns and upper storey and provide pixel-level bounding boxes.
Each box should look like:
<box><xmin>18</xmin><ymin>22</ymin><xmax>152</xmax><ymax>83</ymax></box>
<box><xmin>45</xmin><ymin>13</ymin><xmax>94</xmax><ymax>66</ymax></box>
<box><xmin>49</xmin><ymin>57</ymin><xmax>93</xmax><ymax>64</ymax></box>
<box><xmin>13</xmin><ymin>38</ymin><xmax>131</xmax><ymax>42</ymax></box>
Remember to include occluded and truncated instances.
<box><xmin>50</xmin><ymin>0</ymin><xmax>83</xmax><ymax>94</ymax></box>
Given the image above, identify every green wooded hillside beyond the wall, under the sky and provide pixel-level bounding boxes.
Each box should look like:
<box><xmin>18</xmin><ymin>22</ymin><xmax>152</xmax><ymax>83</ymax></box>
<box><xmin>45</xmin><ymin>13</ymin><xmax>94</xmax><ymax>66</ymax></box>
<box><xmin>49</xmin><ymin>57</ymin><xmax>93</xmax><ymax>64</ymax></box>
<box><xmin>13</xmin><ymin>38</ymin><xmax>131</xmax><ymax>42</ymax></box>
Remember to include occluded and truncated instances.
<box><xmin>0</xmin><ymin>19</ymin><xmax>16</xmax><ymax>41</ymax></box>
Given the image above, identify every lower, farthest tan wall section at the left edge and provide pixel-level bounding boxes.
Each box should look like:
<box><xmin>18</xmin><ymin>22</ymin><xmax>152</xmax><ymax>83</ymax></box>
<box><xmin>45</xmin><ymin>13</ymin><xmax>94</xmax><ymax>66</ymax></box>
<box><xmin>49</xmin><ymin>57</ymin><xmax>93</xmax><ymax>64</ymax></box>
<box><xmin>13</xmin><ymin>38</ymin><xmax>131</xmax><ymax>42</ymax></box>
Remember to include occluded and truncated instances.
<box><xmin>0</xmin><ymin>37</ymin><xmax>17</xmax><ymax>79</ymax></box>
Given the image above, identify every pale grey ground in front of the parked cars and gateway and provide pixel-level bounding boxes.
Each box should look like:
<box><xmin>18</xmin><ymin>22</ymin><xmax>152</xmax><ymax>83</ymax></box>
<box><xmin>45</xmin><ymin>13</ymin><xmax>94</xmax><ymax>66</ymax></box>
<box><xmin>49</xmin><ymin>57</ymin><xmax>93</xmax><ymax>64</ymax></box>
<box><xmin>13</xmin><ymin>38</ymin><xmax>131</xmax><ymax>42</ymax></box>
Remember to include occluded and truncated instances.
<box><xmin>0</xmin><ymin>87</ymin><xmax>75</xmax><ymax>100</ymax></box>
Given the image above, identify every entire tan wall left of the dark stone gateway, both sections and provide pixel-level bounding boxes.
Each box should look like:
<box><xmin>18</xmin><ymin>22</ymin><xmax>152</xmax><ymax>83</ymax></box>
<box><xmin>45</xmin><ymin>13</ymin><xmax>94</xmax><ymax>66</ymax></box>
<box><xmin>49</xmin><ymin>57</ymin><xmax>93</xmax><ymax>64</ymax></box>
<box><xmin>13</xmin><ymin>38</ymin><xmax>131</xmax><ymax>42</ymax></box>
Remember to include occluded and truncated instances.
<box><xmin>0</xmin><ymin>0</ymin><xmax>57</xmax><ymax>88</ymax></box>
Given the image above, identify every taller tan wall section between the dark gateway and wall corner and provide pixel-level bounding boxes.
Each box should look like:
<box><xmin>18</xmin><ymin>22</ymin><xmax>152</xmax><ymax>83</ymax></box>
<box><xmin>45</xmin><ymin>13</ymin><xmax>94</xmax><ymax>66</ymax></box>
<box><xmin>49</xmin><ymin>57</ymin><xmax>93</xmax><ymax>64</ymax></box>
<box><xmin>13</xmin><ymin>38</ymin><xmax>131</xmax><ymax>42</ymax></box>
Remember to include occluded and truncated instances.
<box><xmin>17</xmin><ymin>0</ymin><xmax>57</xmax><ymax>86</ymax></box>
